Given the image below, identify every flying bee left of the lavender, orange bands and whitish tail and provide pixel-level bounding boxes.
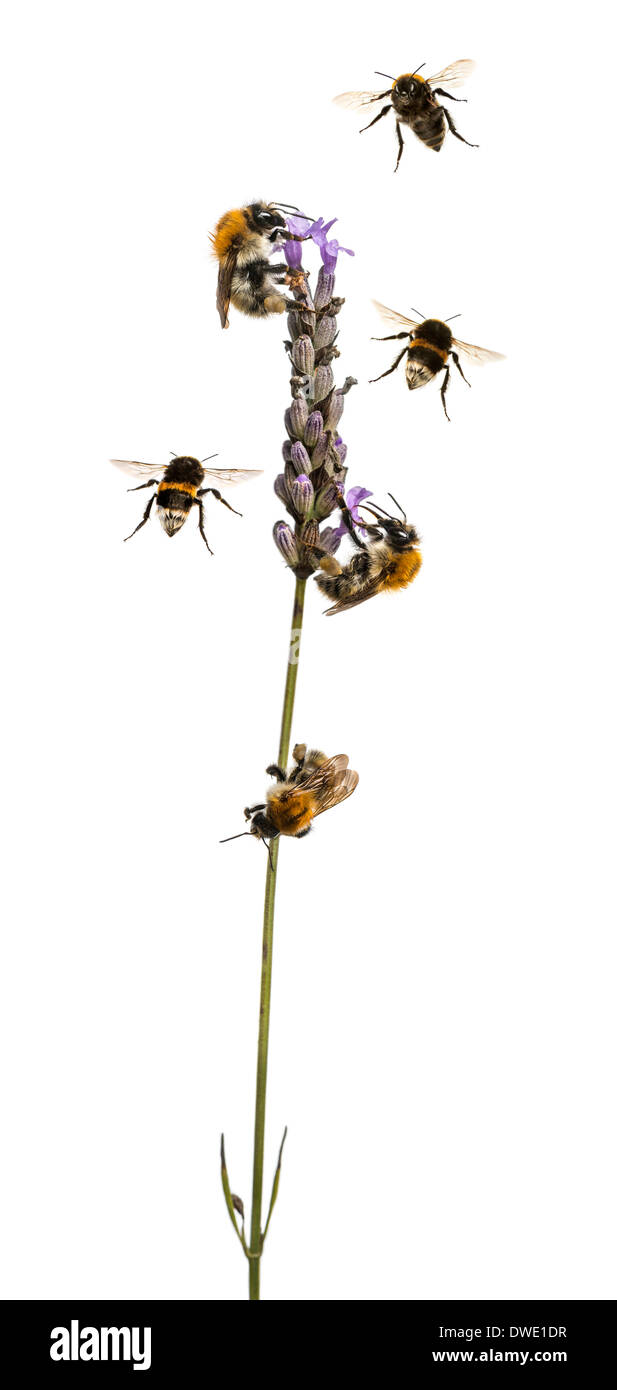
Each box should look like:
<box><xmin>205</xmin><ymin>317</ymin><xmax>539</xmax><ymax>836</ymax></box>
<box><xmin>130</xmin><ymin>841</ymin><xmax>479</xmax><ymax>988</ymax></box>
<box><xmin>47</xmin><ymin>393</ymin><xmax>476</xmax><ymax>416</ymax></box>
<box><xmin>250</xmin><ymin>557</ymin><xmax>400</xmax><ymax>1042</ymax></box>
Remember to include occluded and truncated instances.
<box><xmin>110</xmin><ymin>453</ymin><xmax>263</xmax><ymax>555</ymax></box>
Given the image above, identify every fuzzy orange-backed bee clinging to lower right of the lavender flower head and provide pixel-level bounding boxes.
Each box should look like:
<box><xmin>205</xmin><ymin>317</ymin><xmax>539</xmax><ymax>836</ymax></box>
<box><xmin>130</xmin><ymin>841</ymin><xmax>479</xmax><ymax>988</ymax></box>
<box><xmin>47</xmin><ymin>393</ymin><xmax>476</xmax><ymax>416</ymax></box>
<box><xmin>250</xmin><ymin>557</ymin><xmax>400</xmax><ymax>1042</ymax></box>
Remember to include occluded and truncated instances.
<box><xmin>315</xmin><ymin>493</ymin><xmax>422</xmax><ymax>616</ymax></box>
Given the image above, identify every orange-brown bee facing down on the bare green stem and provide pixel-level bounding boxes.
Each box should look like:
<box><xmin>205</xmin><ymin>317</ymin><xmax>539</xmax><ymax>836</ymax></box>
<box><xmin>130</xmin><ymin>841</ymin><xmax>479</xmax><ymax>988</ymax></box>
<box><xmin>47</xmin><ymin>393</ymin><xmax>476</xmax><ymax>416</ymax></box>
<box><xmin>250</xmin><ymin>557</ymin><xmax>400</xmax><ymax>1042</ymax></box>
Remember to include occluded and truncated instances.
<box><xmin>221</xmin><ymin>744</ymin><xmax>359</xmax><ymax>853</ymax></box>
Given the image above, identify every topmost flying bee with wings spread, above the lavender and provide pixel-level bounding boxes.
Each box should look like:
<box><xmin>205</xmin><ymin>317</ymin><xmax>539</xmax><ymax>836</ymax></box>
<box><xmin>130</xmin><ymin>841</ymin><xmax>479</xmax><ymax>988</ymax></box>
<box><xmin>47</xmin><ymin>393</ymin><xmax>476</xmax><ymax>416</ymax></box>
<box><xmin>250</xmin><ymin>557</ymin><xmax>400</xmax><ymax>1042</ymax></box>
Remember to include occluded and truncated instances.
<box><xmin>335</xmin><ymin>58</ymin><xmax>478</xmax><ymax>174</ymax></box>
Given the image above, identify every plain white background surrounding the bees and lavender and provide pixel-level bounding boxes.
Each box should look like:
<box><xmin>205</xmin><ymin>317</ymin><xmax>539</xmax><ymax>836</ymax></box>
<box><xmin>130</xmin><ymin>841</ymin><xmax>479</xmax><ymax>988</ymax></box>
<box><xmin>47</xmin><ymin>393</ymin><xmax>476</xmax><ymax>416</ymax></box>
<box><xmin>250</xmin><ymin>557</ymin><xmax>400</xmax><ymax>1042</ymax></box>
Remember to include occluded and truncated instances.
<box><xmin>0</xmin><ymin>0</ymin><xmax>617</xmax><ymax>1301</ymax></box>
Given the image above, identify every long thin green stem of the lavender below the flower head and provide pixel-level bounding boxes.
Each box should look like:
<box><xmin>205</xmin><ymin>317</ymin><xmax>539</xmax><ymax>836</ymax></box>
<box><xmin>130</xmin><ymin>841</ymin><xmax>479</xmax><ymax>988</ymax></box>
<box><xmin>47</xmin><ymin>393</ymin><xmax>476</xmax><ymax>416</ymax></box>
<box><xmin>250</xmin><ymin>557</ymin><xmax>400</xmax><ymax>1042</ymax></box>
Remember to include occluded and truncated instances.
<box><xmin>249</xmin><ymin>578</ymin><xmax>306</xmax><ymax>1300</ymax></box>
